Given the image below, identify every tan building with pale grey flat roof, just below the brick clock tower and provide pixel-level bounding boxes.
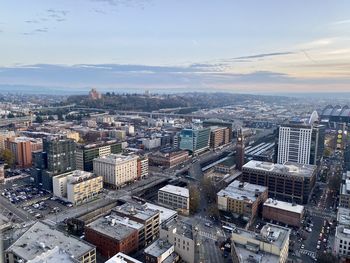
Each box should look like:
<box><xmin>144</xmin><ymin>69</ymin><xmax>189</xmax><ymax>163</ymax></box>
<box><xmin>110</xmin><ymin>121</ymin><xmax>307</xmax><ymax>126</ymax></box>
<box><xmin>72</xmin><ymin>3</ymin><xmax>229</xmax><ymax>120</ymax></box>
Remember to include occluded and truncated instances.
<box><xmin>217</xmin><ymin>181</ymin><xmax>268</xmax><ymax>220</ymax></box>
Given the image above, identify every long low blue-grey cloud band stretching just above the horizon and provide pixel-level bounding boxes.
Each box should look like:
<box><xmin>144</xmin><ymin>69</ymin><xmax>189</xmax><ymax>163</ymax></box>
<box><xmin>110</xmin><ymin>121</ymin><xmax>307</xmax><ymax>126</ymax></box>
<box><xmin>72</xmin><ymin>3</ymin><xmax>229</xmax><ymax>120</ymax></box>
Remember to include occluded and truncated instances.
<box><xmin>0</xmin><ymin>64</ymin><xmax>350</xmax><ymax>91</ymax></box>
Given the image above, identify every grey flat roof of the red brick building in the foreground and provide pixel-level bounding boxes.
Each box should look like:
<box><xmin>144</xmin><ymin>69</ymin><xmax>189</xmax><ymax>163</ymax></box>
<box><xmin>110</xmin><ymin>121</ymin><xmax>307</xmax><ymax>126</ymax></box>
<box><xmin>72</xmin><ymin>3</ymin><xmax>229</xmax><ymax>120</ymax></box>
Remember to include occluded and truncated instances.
<box><xmin>87</xmin><ymin>217</ymin><xmax>136</xmax><ymax>241</ymax></box>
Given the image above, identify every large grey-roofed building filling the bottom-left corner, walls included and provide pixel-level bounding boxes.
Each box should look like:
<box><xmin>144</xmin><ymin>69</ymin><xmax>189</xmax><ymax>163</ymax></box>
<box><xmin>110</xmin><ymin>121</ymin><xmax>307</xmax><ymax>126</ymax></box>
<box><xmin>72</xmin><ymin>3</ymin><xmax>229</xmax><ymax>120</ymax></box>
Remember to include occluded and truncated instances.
<box><xmin>5</xmin><ymin>221</ymin><xmax>96</xmax><ymax>263</ymax></box>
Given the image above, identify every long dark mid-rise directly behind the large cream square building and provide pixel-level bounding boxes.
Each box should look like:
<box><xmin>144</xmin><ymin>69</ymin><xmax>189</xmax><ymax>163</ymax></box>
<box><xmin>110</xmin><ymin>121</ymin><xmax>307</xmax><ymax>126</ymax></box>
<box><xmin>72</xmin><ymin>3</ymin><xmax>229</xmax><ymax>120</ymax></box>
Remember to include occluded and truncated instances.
<box><xmin>75</xmin><ymin>140</ymin><xmax>122</xmax><ymax>172</ymax></box>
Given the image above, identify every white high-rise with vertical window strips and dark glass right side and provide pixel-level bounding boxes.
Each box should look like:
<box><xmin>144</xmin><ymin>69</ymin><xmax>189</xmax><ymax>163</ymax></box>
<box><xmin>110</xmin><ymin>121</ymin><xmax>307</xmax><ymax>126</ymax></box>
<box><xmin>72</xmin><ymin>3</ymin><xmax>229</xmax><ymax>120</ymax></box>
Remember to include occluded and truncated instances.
<box><xmin>277</xmin><ymin>123</ymin><xmax>325</xmax><ymax>165</ymax></box>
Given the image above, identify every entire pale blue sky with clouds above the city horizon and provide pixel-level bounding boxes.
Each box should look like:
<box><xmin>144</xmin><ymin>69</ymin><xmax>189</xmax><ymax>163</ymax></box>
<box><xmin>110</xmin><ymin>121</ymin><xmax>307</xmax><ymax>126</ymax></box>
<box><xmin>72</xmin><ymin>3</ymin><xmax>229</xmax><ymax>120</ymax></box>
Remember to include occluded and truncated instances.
<box><xmin>0</xmin><ymin>0</ymin><xmax>350</xmax><ymax>93</ymax></box>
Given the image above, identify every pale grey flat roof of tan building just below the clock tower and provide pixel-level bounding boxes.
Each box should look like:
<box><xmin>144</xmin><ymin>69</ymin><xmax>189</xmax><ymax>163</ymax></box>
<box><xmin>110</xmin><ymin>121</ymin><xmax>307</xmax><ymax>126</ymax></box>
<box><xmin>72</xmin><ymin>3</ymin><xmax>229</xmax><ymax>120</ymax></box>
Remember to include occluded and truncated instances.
<box><xmin>217</xmin><ymin>181</ymin><xmax>267</xmax><ymax>202</ymax></box>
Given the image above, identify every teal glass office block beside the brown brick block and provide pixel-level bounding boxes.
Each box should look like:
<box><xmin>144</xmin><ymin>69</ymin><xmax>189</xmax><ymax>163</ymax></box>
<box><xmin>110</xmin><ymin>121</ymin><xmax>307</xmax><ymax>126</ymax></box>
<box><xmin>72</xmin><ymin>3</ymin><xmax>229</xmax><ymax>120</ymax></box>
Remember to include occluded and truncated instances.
<box><xmin>179</xmin><ymin>128</ymin><xmax>210</xmax><ymax>154</ymax></box>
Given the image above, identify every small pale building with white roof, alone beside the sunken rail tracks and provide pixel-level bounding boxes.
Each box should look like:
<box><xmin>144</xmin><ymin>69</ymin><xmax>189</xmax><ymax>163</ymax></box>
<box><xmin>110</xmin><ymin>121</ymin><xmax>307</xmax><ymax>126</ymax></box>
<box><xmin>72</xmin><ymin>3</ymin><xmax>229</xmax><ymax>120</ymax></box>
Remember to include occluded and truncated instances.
<box><xmin>158</xmin><ymin>184</ymin><xmax>190</xmax><ymax>215</ymax></box>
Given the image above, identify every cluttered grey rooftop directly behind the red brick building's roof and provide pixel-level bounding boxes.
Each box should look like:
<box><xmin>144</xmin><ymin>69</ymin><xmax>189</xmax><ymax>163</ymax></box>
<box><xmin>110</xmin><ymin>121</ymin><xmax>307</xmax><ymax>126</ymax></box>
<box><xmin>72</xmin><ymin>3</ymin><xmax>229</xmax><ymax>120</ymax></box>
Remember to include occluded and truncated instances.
<box><xmin>112</xmin><ymin>203</ymin><xmax>160</xmax><ymax>221</ymax></box>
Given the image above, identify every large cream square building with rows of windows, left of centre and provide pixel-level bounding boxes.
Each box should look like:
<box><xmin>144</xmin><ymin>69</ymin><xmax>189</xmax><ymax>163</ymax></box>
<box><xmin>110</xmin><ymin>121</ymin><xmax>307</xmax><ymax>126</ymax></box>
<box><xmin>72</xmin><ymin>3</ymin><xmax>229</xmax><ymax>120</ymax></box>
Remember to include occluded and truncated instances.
<box><xmin>93</xmin><ymin>154</ymin><xmax>138</xmax><ymax>189</ymax></box>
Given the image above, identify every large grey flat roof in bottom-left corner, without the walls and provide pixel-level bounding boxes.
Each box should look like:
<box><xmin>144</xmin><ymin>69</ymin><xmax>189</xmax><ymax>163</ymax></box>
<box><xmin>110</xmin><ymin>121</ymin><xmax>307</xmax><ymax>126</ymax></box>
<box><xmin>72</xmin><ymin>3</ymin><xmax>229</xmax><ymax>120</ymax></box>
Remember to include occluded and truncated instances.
<box><xmin>6</xmin><ymin>221</ymin><xmax>95</xmax><ymax>260</ymax></box>
